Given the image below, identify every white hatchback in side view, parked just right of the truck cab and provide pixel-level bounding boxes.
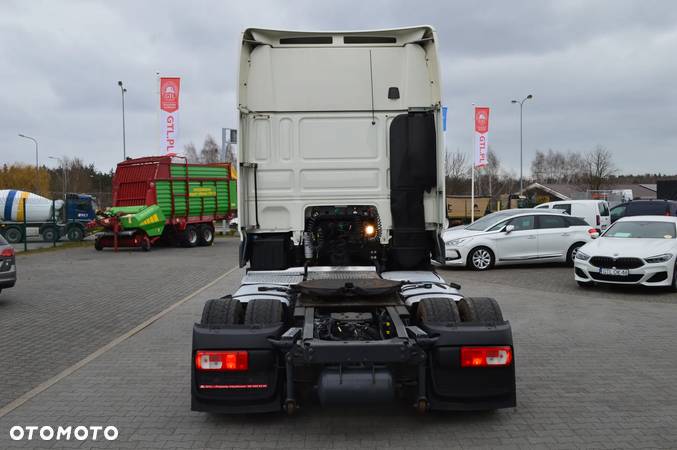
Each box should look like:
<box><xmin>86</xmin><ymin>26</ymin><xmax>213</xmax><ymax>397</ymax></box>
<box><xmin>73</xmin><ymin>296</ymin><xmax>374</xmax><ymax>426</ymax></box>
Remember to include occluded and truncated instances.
<box><xmin>442</xmin><ymin>209</ymin><xmax>597</xmax><ymax>270</ymax></box>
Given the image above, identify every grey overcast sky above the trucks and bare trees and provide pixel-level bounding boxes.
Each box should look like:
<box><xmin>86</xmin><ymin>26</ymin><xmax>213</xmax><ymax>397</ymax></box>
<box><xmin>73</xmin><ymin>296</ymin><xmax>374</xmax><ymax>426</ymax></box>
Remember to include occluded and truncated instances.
<box><xmin>0</xmin><ymin>0</ymin><xmax>677</xmax><ymax>173</ymax></box>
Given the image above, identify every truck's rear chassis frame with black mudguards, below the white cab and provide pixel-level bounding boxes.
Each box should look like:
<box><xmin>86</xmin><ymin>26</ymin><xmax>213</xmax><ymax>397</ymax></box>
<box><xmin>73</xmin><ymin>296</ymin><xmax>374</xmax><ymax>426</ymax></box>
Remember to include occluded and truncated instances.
<box><xmin>191</xmin><ymin>267</ymin><xmax>515</xmax><ymax>414</ymax></box>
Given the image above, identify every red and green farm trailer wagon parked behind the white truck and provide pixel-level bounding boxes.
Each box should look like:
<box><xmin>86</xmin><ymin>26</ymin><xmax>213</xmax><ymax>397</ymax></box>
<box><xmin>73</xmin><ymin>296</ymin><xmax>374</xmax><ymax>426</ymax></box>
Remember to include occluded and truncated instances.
<box><xmin>88</xmin><ymin>155</ymin><xmax>237</xmax><ymax>251</ymax></box>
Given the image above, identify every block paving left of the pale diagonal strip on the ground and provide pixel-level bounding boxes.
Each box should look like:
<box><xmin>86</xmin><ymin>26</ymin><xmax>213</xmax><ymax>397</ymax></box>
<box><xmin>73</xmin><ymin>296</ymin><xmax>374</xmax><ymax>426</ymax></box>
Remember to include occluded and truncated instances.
<box><xmin>0</xmin><ymin>238</ymin><xmax>238</xmax><ymax>407</ymax></box>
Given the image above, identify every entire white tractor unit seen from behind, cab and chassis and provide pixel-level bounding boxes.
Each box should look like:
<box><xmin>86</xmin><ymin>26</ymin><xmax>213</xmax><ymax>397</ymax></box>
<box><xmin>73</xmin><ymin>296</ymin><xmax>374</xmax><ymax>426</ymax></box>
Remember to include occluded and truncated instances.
<box><xmin>191</xmin><ymin>26</ymin><xmax>515</xmax><ymax>413</ymax></box>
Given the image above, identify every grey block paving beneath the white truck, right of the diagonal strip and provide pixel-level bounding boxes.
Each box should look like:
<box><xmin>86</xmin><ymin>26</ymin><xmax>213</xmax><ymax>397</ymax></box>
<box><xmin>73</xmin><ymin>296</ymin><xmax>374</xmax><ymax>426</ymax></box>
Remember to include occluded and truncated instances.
<box><xmin>0</xmin><ymin>252</ymin><xmax>677</xmax><ymax>449</ymax></box>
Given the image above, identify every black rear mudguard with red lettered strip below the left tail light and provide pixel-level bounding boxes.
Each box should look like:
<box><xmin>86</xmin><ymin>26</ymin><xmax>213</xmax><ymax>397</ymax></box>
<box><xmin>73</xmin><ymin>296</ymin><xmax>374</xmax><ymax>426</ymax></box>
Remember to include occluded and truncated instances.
<box><xmin>191</xmin><ymin>323</ymin><xmax>283</xmax><ymax>414</ymax></box>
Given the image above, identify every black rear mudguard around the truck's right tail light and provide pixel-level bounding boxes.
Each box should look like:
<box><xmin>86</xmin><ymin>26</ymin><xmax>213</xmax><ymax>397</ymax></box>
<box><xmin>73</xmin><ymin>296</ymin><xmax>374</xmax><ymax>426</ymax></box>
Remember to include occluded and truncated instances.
<box><xmin>423</xmin><ymin>322</ymin><xmax>516</xmax><ymax>411</ymax></box>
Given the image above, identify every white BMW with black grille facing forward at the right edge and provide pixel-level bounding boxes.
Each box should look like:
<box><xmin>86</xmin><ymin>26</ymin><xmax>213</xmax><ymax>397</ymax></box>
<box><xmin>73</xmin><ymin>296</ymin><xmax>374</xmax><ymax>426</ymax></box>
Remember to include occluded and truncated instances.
<box><xmin>574</xmin><ymin>216</ymin><xmax>677</xmax><ymax>291</ymax></box>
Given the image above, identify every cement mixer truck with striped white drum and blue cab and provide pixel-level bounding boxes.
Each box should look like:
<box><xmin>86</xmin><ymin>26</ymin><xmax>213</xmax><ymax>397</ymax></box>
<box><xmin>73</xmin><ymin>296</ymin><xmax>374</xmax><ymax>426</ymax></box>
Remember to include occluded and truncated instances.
<box><xmin>0</xmin><ymin>189</ymin><xmax>98</xmax><ymax>244</ymax></box>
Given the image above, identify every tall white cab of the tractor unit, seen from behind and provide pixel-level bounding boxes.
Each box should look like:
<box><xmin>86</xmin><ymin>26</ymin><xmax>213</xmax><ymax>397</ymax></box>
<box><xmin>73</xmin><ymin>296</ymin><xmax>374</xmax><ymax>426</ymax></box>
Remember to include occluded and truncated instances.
<box><xmin>238</xmin><ymin>27</ymin><xmax>446</xmax><ymax>270</ymax></box>
